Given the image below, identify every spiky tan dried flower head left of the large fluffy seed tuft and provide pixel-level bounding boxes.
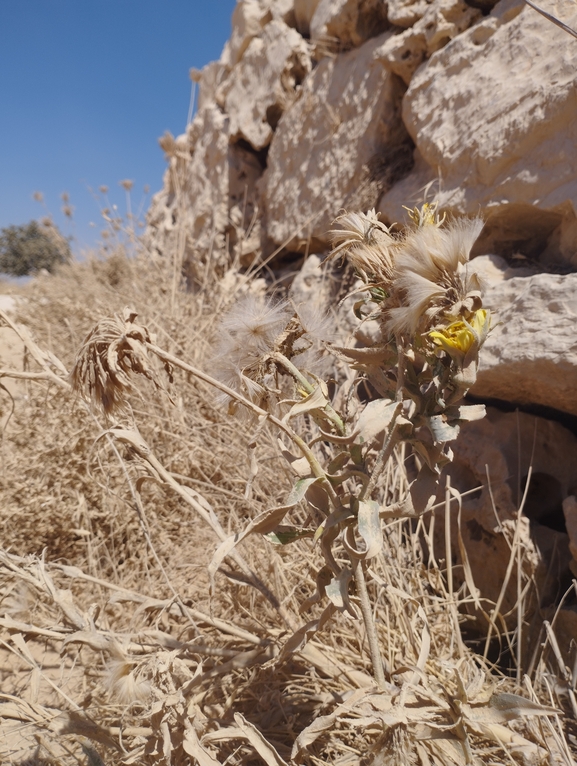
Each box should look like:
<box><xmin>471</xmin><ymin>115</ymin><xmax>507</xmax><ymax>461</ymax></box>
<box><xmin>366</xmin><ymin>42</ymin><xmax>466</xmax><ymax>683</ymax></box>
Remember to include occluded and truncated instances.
<box><xmin>329</xmin><ymin>210</ymin><xmax>397</xmax><ymax>290</ymax></box>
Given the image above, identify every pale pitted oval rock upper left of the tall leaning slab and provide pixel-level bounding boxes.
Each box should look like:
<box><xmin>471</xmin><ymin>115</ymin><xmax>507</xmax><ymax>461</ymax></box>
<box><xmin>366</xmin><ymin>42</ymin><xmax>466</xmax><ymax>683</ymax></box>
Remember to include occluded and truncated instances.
<box><xmin>225</xmin><ymin>20</ymin><xmax>311</xmax><ymax>150</ymax></box>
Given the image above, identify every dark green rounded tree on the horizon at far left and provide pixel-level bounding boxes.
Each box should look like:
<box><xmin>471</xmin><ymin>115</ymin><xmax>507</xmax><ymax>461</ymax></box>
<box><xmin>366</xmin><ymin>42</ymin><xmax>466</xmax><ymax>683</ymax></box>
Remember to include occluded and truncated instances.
<box><xmin>0</xmin><ymin>218</ymin><xmax>71</xmax><ymax>277</ymax></box>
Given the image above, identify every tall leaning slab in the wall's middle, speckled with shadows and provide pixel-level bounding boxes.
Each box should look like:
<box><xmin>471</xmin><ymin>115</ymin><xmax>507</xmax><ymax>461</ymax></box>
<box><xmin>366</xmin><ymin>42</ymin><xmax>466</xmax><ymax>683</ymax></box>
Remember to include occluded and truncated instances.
<box><xmin>262</xmin><ymin>32</ymin><xmax>407</xmax><ymax>252</ymax></box>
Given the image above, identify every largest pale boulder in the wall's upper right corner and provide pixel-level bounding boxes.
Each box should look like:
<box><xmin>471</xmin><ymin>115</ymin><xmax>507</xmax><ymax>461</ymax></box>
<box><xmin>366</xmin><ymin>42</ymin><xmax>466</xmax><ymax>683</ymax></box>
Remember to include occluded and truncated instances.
<box><xmin>380</xmin><ymin>0</ymin><xmax>577</xmax><ymax>259</ymax></box>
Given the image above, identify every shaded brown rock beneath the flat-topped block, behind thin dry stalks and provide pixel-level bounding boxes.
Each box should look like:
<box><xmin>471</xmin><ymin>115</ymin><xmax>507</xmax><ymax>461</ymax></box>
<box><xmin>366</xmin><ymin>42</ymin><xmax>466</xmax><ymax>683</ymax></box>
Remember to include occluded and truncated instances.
<box><xmin>436</xmin><ymin>407</ymin><xmax>577</xmax><ymax>614</ymax></box>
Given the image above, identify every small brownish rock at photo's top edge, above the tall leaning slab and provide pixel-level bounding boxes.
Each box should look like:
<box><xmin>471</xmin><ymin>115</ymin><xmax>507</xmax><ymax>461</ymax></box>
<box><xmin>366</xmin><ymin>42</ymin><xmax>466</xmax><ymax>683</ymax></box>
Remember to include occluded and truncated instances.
<box><xmin>310</xmin><ymin>0</ymin><xmax>388</xmax><ymax>49</ymax></box>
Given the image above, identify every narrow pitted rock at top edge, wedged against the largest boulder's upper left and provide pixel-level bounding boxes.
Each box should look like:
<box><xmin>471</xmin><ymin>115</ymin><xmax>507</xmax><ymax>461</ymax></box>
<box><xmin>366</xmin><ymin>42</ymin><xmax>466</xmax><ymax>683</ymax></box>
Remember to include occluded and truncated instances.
<box><xmin>375</xmin><ymin>0</ymin><xmax>481</xmax><ymax>85</ymax></box>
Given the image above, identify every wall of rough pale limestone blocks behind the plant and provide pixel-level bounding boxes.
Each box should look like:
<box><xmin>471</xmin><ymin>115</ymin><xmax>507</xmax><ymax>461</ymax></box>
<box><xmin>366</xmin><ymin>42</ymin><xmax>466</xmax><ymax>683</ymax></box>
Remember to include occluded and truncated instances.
<box><xmin>148</xmin><ymin>0</ymin><xmax>577</xmax><ymax>637</ymax></box>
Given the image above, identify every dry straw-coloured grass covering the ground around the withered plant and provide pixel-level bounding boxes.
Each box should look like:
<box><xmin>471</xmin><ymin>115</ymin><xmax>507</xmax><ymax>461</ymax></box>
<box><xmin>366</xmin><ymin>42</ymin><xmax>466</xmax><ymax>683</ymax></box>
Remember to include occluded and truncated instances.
<box><xmin>0</xmin><ymin>234</ymin><xmax>573</xmax><ymax>766</ymax></box>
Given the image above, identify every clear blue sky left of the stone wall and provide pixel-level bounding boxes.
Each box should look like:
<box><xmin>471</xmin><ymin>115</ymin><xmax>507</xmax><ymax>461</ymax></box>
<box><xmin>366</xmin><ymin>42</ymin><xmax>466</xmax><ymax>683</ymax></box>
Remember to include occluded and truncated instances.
<box><xmin>0</xmin><ymin>0</ymin><xmax>235</xmax><ymax>252</ymax></box>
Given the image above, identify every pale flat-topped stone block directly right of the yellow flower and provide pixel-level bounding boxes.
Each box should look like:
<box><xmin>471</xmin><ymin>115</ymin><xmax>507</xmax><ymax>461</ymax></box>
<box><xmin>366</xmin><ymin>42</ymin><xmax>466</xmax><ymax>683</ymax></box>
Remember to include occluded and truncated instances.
<box><xmin>471</xmin><ymin>272</ymin><xmax>577</xmax><ymax>415</ymax></box>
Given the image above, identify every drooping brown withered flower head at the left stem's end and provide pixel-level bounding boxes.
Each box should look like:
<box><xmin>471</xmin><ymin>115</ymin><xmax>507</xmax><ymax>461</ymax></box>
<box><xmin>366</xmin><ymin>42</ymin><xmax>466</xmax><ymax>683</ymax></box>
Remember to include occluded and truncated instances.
<box><xmin>70</xmin><ymin>308</ymin><xmax>170</xmax><ymax>415</ymax></box>
